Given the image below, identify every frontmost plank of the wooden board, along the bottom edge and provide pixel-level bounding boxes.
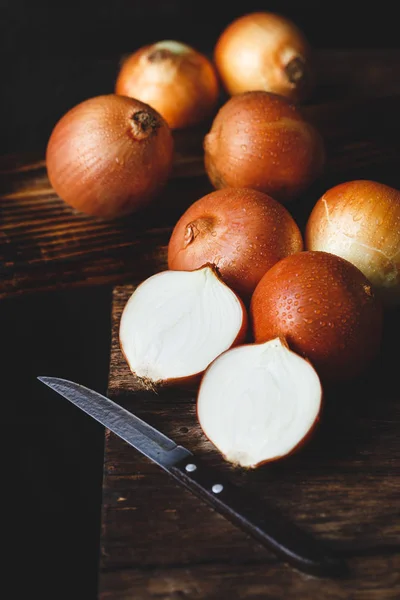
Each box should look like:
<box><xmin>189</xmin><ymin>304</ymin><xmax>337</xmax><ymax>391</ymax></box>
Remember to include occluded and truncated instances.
<box><xmin>100</xmin><ymin>556</ymin><xmax>400</xmax><ymax>600</ymax></box>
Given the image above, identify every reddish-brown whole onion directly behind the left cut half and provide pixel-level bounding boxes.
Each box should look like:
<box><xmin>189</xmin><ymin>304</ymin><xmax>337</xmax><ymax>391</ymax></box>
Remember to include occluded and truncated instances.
<box><xmin>168</xmin><ymin>188</ymin><xmax>303</xmax><ymax>298</ymax></box>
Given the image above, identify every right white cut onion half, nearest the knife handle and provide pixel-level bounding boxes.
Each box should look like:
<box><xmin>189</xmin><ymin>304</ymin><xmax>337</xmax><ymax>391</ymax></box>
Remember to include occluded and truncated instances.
<box><xmin>197</xmin><ymin>338</ymin><xmax>322</xmax><ymax>467</ymax></box>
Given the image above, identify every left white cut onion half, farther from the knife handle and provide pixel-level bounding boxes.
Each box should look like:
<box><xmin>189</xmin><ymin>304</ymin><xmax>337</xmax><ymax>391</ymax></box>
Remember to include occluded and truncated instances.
<box><xmin>119</xmin><ymin>265</ymin><xmax>247</xmax><ymax>387</ymax></box>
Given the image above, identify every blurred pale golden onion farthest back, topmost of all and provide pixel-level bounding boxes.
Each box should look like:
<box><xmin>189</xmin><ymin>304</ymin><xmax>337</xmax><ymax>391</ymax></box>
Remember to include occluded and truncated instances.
<box><xmin>215</xmin><ymin>12</ymin><xmax>315</xmax><ymax>102</ymax></box>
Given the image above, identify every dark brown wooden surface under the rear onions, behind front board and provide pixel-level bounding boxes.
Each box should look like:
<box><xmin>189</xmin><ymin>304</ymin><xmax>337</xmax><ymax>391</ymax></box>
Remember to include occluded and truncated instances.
<box><xmin>0</xmin><ymin>51</ymin><xmax>400</xmax><ymax>299</ymax></box>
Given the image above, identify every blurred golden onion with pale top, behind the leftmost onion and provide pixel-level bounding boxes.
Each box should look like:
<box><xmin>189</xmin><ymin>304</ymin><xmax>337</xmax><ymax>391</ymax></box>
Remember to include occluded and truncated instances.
<box><xmin>115</xmin><ymin>40</ymin><xmax>219</xmax><ymax>129</ymax></box>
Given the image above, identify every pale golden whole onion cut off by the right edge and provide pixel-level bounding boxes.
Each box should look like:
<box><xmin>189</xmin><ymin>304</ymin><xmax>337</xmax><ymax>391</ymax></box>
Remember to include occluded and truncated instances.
<box><xmin>306</xmin><ymin>181</ymin><xmax>400</xmax><ymax>306</ymax></box>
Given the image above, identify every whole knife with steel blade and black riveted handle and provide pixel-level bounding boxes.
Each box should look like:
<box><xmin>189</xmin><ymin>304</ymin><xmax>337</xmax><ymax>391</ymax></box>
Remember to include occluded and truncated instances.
<box><xmin>38</xmin><ymin>377</ymin><xmax>347</xmax><ymax>577</ymax></box>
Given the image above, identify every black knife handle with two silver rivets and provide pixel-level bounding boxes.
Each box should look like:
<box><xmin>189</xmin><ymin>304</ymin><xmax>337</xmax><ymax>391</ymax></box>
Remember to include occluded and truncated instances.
<box><xmin>167</xmin><ymin>457</ymin><xmax>346</xmax><ymax>576</ymax></box>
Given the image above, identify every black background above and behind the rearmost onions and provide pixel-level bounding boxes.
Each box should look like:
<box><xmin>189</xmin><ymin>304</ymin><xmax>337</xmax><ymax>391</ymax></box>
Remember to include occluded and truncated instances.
<box><xmin>0</xmin><ymin>0</ymin><xmax>399</xmax><ymax>157</ymax></box>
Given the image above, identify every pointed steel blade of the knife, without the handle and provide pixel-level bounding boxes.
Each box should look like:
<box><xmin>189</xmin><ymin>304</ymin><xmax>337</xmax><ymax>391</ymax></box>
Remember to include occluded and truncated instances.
<box><xmin>38</xmin><ymin>377</ymin><xmax>193</xmax><ymax>468</ymax></box>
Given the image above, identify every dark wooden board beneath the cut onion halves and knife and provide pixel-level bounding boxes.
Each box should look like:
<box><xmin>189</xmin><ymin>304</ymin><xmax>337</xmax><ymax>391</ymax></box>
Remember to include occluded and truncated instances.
<box><xmin>100</xmin><ymin>286</ymin><xmax>400</xmax><ymax>600</ymax></box>
